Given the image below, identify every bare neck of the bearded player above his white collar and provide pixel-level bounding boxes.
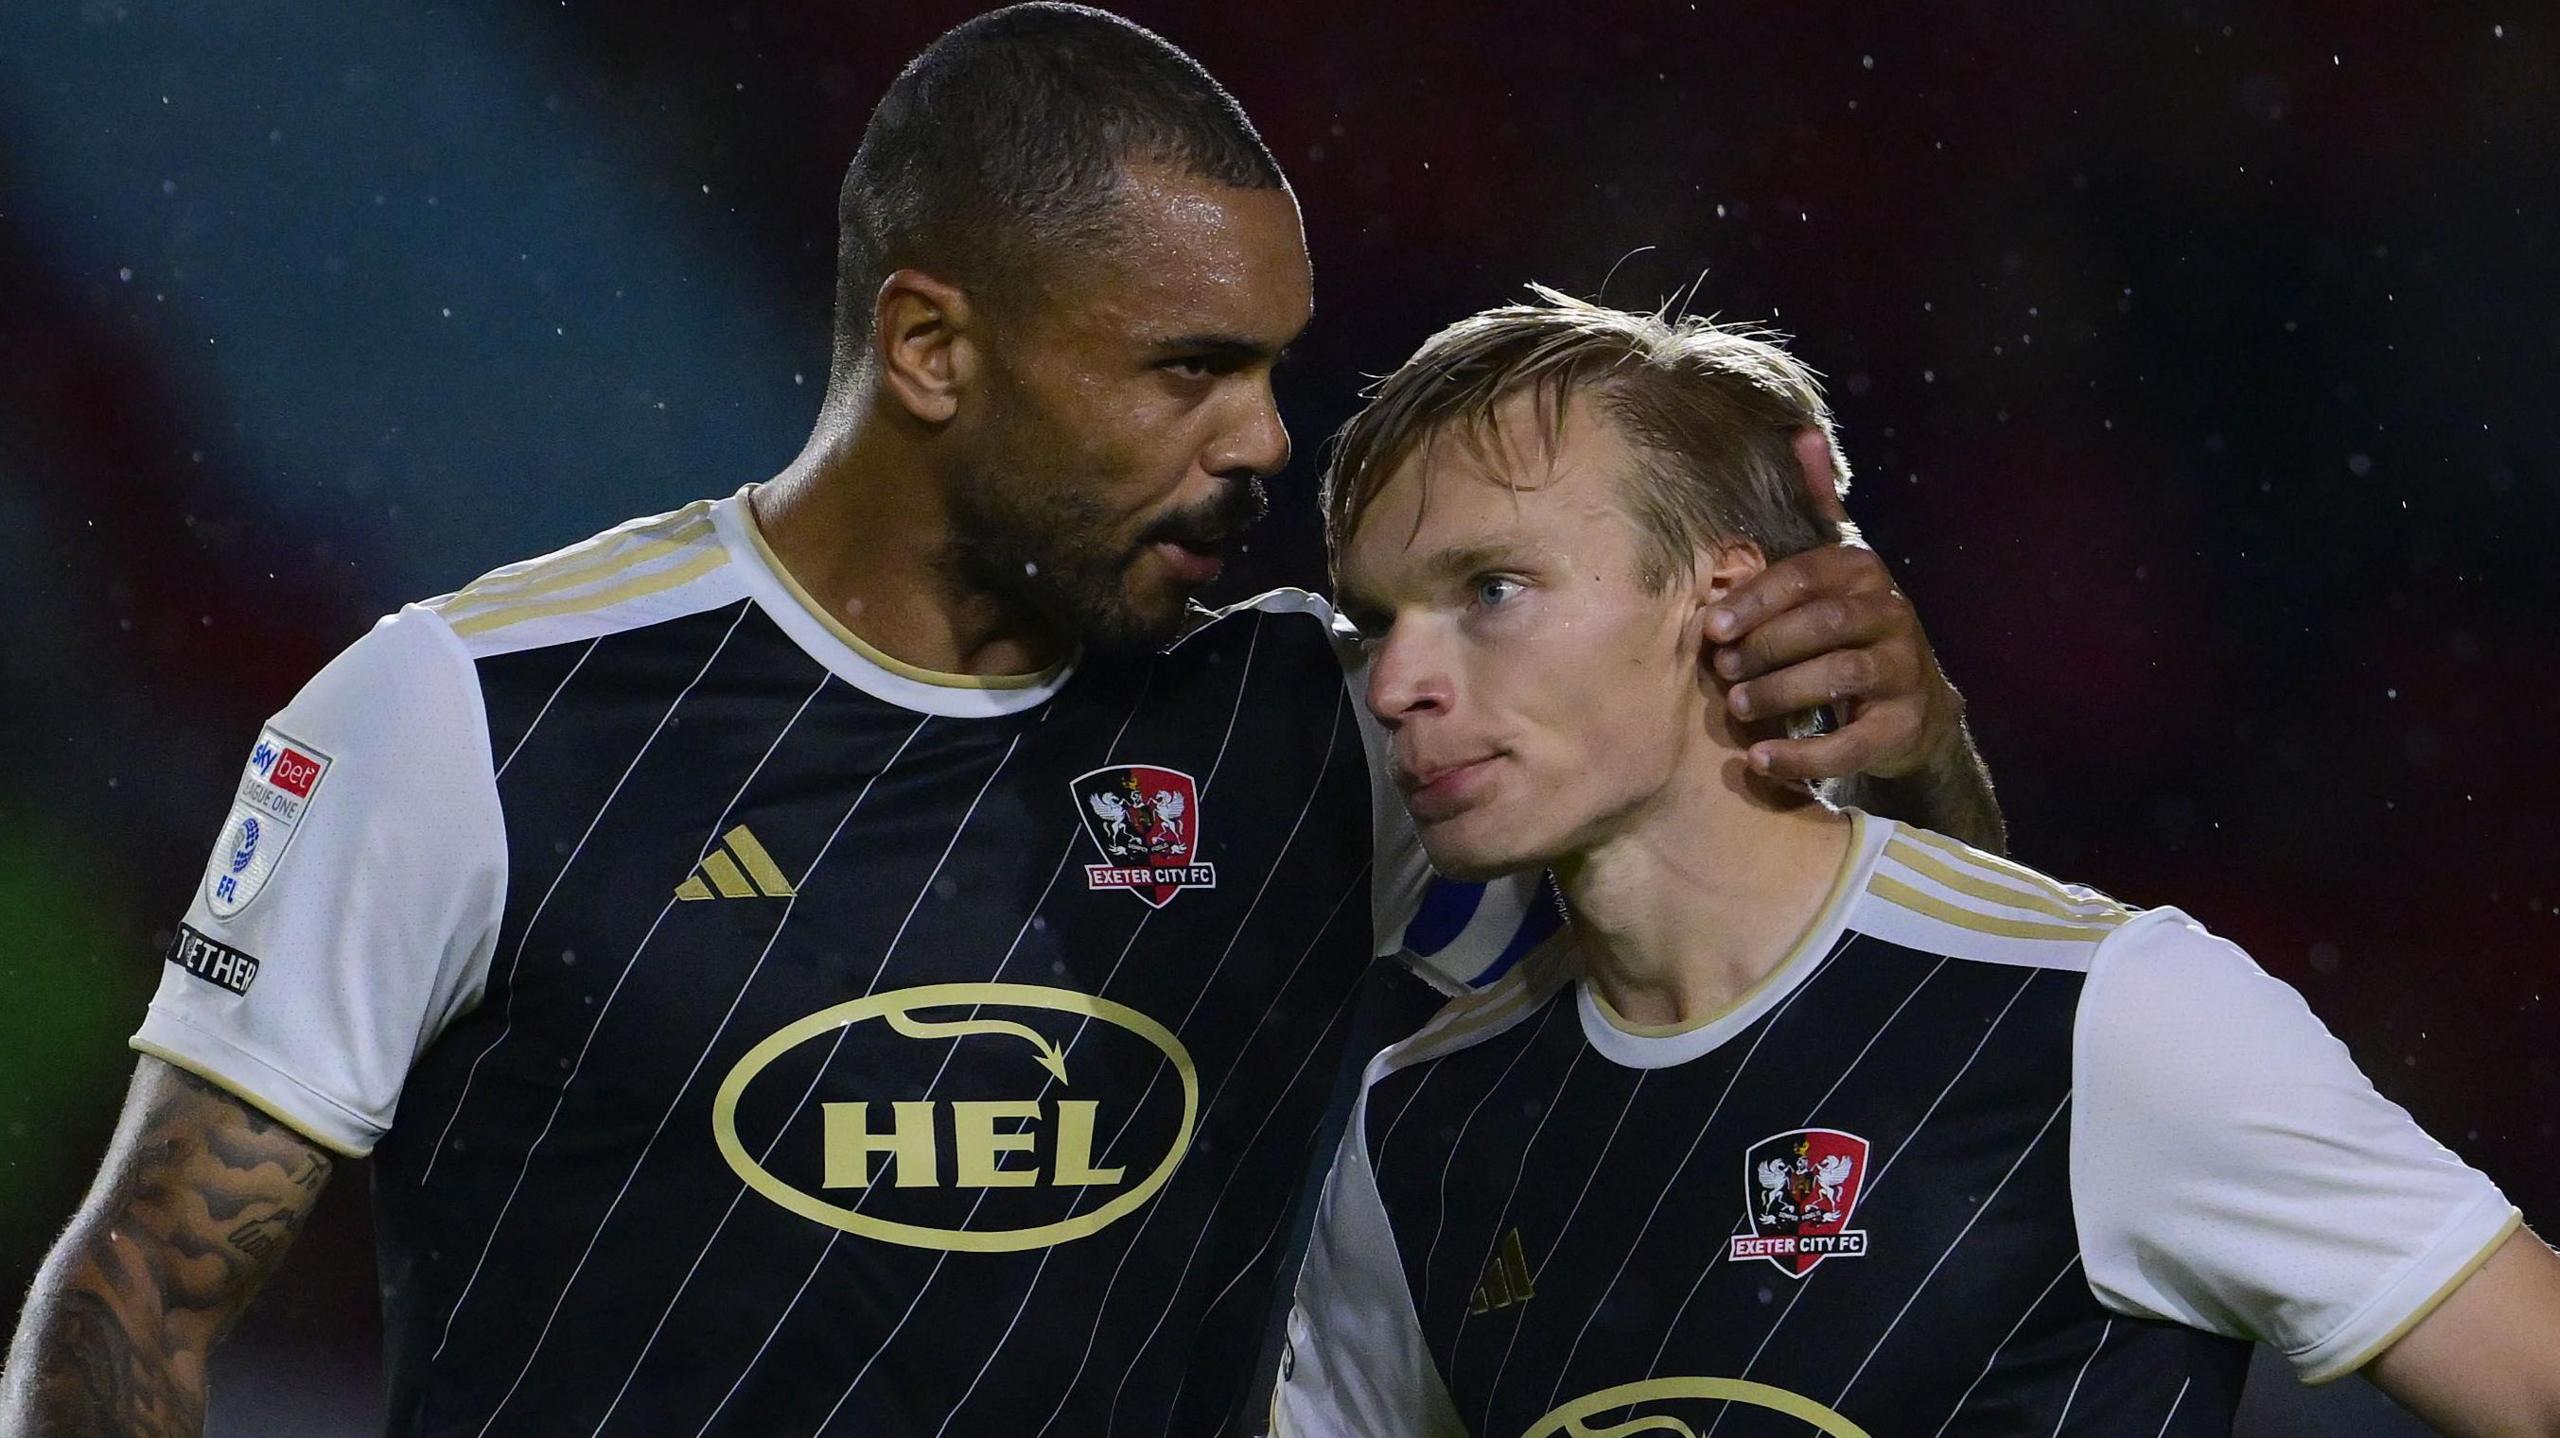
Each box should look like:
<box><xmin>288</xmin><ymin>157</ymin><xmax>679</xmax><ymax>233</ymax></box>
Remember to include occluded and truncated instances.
<box><xmin>748</xmin><ymin>399</ymin><xmax>1073</xmax><ymax>676</ymax></box>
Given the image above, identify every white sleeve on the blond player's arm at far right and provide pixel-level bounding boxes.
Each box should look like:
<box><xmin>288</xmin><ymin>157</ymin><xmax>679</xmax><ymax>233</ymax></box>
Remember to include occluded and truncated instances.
<box><xmin>2071</xmin><ymin>908</ymin><xmax>2519</xmax><ymax>1382</ymax></box>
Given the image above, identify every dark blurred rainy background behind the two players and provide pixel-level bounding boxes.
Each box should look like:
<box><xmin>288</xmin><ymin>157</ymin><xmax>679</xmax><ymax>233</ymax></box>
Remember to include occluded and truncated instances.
<box><xmin>0</xmin><ymin>0</ymin><xmax>2560</xmax><ymax>1435</ymax></box>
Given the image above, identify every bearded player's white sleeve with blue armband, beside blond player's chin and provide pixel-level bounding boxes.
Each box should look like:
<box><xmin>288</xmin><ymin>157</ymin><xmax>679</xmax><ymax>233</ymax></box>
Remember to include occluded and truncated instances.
<box><xmin>1336</xmin><ymin>621</ymin><xmax>1564</xmax><ymax>993</ymax></box>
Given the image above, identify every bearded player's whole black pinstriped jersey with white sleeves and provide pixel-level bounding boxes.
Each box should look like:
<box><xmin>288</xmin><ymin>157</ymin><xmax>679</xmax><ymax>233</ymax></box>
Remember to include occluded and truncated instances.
<box><xmin>136</xmin><ymin>483</ymin><xmax>1551</xmax><ymax>1435</ymax></box>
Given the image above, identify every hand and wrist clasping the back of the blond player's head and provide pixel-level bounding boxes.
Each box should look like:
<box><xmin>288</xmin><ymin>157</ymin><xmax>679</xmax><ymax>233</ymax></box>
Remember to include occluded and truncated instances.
<box><xmin>1708</xmin><ymin>430</ymin><xmax>2007</xmax><ymax>852</ymax></box>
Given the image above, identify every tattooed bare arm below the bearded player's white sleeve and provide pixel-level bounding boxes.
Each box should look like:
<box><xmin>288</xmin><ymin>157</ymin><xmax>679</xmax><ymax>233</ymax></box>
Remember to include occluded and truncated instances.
<box><xmin>0</xmin><ymin>1057</ymin><xmax>333</xmax><ymax>1438</ymax></box>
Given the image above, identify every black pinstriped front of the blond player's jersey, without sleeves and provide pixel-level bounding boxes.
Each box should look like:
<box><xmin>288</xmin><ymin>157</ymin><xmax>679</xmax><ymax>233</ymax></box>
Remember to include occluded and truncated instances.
<box><xmin>1341</xmin><ymin>829</ymin><xmax>2245</xmax><ymax>1438</ymax></box>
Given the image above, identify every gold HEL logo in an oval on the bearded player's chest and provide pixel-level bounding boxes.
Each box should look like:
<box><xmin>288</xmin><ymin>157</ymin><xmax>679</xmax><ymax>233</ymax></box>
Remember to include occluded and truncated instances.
<box><xmin>712</xmin><ymin>983</ymin><xmax>1201</xmax><ymax>1254</ymax></box>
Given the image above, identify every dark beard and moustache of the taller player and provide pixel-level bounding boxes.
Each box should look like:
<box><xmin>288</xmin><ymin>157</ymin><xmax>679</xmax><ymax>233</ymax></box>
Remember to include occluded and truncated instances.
<box><xmin>950</xmin><ymin>424</ymin><xmax>1270</xmax><ymax>655</ymax></box>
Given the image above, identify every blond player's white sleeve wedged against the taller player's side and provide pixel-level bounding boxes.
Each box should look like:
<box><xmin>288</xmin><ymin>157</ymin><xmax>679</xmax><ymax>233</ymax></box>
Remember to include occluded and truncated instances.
<box><xmin>1272</xmin><ymin>1095</ymin><xmax>1467</xmax><ymax>1438</ymax></box>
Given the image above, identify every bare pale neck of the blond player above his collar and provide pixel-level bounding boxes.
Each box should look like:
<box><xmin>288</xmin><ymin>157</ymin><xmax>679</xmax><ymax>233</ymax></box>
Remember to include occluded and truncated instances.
<box><xmin>1559</xmin><ymin>765</ymin><xmax>1856</xmax><ymax>1026</ymax></box>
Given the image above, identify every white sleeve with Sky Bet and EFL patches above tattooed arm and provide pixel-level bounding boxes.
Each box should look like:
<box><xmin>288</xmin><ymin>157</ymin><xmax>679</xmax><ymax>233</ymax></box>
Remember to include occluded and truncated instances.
<box><xmin>133</xmin><ymin>606</ymin><xmax>507</xmax><ymax>1154</ymax></box>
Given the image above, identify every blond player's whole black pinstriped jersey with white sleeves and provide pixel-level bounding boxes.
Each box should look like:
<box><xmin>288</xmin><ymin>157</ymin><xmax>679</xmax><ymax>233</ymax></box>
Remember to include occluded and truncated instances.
<box><xmin>1275</xmin><ymin>816</ymin><xmax>2516</xmax><ymax>1438</ymax></box>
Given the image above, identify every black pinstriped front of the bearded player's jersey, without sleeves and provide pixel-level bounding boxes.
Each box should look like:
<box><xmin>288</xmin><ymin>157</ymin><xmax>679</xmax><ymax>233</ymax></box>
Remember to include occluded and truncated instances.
<box><xmin>379</xmin><ymin>555</ymin><xmax>1423</xmax><ymax>1438</ymax></box>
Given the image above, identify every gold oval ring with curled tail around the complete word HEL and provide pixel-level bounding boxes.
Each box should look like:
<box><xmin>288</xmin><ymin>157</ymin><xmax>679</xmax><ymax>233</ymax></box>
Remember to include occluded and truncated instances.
<box><xmin>712</xmin><ymin>983</ymin><xmax>1201</xmax><ymax>1254</ymax></box>
